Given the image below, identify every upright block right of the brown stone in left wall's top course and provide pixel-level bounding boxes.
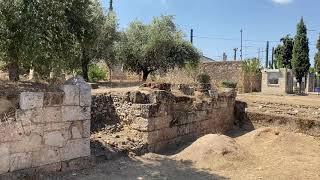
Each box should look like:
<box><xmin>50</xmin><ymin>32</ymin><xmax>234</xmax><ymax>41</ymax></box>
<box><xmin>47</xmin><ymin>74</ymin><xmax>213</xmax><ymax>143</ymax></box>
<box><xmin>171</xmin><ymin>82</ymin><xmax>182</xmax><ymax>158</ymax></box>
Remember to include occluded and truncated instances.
<box><xmin>61</xmin><ymin>85</ymin><xmax>80</xmax><ymax>106</ymax></box>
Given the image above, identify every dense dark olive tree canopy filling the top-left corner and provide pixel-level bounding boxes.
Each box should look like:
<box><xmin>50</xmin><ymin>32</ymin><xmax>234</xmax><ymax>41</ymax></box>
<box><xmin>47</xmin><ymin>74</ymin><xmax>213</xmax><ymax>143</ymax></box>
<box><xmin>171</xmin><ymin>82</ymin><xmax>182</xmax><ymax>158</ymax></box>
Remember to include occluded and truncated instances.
<box><xmin>0</xmin><ymin>0</ymin><xmax>117</xmax><ymax>80</ymax></box>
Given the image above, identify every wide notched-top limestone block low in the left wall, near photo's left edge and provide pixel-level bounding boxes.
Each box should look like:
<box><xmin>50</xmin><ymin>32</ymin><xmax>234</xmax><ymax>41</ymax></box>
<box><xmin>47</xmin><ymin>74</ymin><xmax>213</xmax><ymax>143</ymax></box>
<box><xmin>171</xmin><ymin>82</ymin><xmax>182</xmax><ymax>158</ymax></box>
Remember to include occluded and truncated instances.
<box><xmin>10</xmin><ymin>133</ymin><xmax>42</xmax><ymax>153</ymax></box>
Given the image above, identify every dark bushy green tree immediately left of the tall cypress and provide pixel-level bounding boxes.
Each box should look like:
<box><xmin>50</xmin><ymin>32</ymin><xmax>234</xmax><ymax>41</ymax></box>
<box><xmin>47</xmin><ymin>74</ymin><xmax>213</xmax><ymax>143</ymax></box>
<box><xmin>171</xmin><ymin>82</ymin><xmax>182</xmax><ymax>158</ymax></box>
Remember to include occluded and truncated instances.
<box><xmin>275</xmin><ymin>35</ymin><xmax>294</xmax><ymax>69</ymax></box>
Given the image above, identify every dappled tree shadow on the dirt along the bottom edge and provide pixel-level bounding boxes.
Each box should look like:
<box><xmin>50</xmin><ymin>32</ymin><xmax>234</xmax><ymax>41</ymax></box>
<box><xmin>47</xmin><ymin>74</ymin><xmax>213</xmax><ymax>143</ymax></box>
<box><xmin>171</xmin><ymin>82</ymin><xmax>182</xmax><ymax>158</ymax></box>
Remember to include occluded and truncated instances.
<box><xmin>46</xmin><ymin>155</ymin><xmax>228</xmax><ymax>180</ymax></box>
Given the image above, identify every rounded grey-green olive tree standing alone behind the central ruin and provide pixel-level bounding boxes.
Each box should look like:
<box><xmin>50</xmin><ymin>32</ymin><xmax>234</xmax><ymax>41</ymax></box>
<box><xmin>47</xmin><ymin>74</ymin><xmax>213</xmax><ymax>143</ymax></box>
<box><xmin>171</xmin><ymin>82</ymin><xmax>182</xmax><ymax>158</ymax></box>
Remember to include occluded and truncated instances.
<box><xmin>117</xmin><ymin>16</ymin><xmax>200</xmax><ymax>80</ymax></box>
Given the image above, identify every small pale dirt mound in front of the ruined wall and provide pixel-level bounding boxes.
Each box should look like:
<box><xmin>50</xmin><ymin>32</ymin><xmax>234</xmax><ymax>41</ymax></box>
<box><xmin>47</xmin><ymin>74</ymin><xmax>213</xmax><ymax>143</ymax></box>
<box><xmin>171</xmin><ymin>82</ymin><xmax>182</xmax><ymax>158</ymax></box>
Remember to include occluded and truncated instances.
<box><xmin>173</xmin><ymin>134</ymin><xmax>252</xmax><ymax>169</ymax></box>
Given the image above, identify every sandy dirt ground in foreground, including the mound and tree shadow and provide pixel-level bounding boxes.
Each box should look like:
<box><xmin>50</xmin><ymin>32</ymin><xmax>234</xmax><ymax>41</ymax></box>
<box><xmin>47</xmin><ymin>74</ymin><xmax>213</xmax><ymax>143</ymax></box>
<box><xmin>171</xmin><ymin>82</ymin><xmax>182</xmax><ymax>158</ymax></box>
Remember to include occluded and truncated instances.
<box><xmin>54</xmin><ymin>128</ymin><xmax>320</xmax><ymax>180</ymax></box>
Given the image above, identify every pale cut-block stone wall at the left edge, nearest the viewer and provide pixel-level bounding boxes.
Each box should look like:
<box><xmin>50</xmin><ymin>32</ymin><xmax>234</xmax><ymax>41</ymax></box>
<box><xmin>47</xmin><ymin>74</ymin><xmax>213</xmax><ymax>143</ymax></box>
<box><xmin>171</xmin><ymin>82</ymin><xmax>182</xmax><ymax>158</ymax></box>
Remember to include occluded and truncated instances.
<box><xmin>0</xmin><ymin>78</ymin><xmax>91</xmax><ymax>174</ymax></box>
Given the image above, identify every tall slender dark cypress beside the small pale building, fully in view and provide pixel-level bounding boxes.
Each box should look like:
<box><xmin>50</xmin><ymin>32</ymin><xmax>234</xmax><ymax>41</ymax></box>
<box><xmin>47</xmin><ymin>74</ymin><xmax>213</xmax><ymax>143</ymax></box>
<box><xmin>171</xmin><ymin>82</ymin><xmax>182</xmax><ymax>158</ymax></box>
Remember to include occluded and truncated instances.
<box><xmin>292</xmin><ymin>18</ymin><xmax>310</xmax><ymax>93</ymax></box>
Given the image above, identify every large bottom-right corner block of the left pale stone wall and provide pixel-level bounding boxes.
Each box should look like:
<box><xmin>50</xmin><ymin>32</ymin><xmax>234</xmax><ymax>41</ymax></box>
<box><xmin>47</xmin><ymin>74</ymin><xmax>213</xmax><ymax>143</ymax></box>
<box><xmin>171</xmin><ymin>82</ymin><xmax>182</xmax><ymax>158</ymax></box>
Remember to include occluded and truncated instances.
<box><xmin>60</xmin><ymin>138</ymin><xmax>90</xmax><ymax>161</ymax></box>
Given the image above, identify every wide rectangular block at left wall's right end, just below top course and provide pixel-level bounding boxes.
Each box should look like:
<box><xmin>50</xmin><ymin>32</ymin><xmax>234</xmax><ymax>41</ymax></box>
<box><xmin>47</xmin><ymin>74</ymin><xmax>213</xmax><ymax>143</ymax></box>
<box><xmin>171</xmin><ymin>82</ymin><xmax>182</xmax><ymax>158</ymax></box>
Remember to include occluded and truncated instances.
<box><xmin>62</xmin><ymin>106</ymin><xmax>91</xmax><ymax>121</ymax></box>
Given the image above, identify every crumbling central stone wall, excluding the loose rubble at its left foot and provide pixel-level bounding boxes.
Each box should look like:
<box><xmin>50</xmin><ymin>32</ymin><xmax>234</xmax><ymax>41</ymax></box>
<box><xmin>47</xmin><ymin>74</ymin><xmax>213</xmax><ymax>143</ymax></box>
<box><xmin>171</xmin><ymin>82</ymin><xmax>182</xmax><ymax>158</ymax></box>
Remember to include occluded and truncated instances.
<box><xmin>92</xmin><ymin>87</ymin><xmax>236</xmax><ymax>152</ymax></box>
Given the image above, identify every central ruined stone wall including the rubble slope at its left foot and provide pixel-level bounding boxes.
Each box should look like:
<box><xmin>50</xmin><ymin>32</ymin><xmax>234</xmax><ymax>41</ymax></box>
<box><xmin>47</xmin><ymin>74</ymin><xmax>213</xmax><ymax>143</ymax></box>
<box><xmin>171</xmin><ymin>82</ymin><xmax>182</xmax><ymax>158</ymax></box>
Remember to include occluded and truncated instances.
<box><xmin>91</xmin><ymin>83</ymin><xmax>236</xmax><ymax>154</ymax></box>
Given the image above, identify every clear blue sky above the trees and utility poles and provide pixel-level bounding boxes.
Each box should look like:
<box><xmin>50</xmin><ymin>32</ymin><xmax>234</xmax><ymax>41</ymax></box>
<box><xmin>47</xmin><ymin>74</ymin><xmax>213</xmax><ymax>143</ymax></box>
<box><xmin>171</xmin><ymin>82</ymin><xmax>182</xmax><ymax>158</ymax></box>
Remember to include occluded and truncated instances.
<box><xmin>103</xmin><ymin>0</ymin><xmax>320</xmax><ymax>66</ymax></box>
